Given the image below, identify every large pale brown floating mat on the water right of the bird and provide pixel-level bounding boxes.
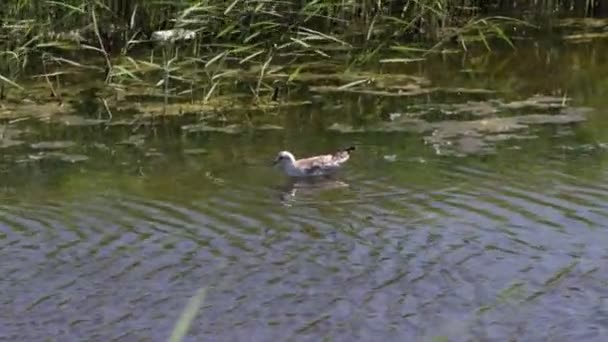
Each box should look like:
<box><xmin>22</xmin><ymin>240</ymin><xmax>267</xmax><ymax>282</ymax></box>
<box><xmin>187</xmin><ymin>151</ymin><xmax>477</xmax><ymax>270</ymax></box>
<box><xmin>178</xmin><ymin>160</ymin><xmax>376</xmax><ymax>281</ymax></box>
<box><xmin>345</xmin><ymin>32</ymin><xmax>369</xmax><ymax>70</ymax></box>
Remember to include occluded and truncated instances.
<box><xmin>327</xmin><ymin>96</ymin><xmax>591</xmax><ymax>156</ymax></box>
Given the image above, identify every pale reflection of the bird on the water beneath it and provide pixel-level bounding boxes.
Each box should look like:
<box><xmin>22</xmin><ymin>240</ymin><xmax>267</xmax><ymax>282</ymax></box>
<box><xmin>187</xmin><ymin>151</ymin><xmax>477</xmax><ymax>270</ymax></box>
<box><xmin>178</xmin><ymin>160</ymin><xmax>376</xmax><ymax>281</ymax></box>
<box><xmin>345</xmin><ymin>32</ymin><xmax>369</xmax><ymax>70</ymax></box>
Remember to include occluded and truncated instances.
<box><xmin>280</xmin><ymin>177</ymin><xmax>348</xmax><ymax>206</ymax></box>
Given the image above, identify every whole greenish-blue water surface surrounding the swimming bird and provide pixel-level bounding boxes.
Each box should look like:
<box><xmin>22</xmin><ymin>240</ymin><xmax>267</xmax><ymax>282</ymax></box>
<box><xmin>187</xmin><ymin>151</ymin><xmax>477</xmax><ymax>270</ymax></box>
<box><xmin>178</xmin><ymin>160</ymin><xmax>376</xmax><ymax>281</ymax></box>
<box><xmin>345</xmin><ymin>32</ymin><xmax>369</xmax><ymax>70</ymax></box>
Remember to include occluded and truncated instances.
<box><xmin>0</xmin><ymin>38</ymin><xmax>608</xmax><ymax>341</ymax></box>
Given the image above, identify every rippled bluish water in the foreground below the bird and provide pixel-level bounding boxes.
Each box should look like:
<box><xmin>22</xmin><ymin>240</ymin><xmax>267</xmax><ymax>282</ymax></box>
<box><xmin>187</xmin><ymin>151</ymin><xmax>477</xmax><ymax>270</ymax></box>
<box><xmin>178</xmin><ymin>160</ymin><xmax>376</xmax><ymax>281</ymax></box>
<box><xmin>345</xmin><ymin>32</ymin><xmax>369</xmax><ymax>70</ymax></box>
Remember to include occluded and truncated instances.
<box><xmin>0</xmin><ymin>153</ymin><xmax>608</xmax><ymax>341</ymax></box>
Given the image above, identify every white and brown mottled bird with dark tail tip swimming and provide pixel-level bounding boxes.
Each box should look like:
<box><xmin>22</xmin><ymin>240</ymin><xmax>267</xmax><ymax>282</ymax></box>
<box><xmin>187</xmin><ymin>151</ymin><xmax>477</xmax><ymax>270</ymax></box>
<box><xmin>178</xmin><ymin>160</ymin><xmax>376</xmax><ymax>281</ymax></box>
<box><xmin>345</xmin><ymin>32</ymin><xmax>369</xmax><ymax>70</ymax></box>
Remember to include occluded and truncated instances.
<box><xmin>273</xmin><ymin>146</ymin><xmax>355</xmax><ymax>177</ymax></box>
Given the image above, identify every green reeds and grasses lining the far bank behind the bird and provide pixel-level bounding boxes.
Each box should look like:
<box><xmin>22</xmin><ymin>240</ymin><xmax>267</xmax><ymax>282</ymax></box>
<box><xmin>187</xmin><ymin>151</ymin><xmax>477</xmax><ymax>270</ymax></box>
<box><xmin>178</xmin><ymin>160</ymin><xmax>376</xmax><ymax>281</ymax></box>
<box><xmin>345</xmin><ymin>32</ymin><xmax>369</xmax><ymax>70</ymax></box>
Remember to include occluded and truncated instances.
<box><xmin>0</xmin><ymin>0</ymin><xmax>606</xmax><ymax>120</ymax></box>
